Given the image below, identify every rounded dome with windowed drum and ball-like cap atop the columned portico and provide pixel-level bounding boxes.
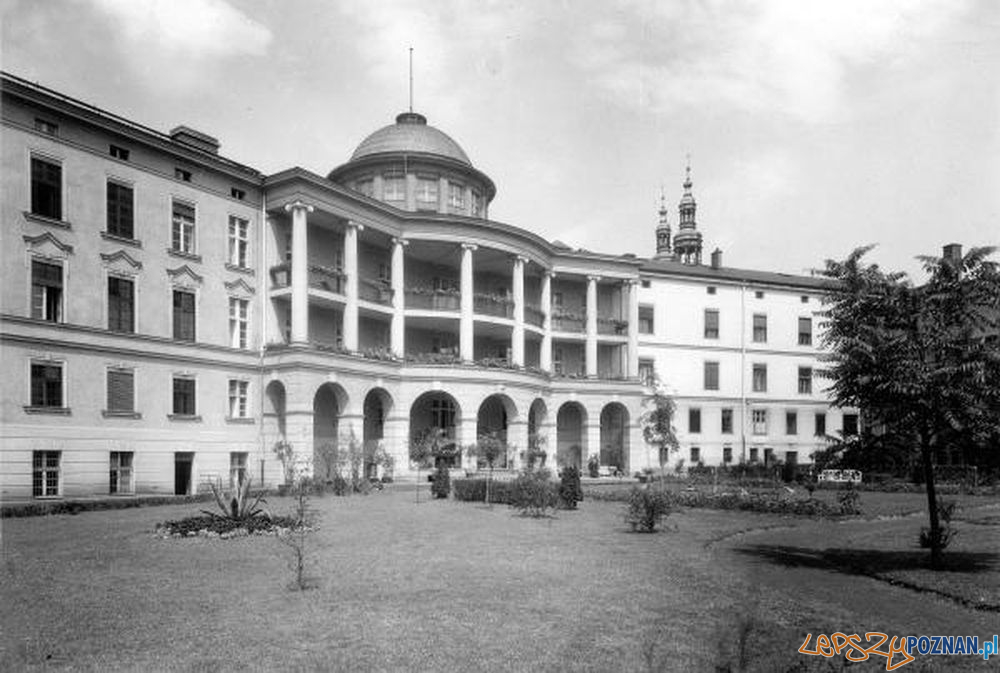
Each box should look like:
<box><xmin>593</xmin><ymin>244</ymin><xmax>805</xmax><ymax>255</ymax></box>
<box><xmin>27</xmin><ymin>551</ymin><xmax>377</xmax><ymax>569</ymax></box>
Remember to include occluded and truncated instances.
<box><xmin>327</xmin><ymin>112</ymin><xmax>496</xmax><ymax>219</ymax></box>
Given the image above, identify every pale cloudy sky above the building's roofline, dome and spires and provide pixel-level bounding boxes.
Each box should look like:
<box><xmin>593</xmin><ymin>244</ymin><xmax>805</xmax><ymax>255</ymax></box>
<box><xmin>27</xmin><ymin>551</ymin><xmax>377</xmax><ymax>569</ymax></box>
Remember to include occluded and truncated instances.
<box><xmin>0</xmin><ymin>0</ymin><xmax>1000</xmax><ymax>277</ymax></box>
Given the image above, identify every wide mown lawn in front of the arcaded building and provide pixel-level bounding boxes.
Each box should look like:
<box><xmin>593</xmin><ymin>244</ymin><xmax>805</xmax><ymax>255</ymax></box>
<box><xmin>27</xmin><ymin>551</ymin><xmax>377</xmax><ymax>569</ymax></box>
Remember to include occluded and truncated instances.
<box><xmin>0</xmin><ymin>487</ymin><xmax>1000</xmax><ymax>671</ymax></box>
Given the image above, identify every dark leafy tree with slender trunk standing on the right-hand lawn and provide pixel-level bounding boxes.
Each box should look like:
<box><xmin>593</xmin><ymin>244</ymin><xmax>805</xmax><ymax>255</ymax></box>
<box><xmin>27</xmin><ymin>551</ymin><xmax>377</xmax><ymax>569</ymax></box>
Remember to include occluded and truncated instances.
<box><xmin>823</xmin><ymin>246</ymin><xmax>1000</xmax><ymax>567</ymax></box>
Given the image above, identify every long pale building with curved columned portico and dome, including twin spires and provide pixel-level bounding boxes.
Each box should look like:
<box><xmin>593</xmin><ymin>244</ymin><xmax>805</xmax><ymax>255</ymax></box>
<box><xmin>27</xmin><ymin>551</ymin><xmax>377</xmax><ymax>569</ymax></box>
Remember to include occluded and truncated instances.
<box><xmin>0</xmin><ymin>74</ymin><xmax>852</xmax><ymax>500</ymax></box>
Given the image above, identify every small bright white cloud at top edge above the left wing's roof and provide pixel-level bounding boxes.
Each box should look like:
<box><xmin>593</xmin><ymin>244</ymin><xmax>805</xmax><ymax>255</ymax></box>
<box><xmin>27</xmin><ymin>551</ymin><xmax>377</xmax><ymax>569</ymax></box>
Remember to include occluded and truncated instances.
<box><xmin>88</xmin><ymin>0</ymin><xmax>272</xmax><ymax>59</ymax></box>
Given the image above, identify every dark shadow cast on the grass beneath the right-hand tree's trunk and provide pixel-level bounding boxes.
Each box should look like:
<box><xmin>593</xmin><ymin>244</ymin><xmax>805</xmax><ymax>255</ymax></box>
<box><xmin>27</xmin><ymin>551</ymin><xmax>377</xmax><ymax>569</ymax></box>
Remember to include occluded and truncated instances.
<box><xmin>736</xmin><ymin>545</ymin><xmax>1000</xmax><ymax>612</ymax></box>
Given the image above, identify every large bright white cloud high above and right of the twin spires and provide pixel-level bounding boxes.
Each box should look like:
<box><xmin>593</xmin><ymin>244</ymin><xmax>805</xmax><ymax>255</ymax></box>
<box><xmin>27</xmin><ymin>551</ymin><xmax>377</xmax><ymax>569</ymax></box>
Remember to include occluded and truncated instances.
<box><xmin>572</xmin><ymin>0</ymin><xmax>968</xmax><ymax>122</ymax></box>
